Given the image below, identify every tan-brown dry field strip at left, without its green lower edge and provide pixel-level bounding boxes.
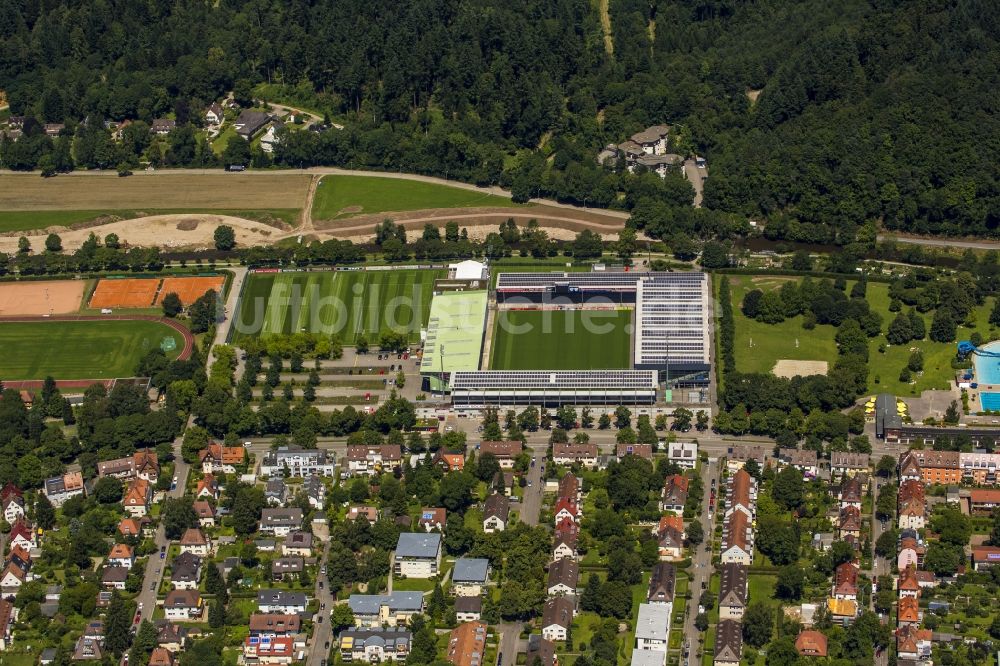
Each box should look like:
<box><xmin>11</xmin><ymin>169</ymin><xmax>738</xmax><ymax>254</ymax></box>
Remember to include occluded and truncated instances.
<box><xmin>0</xmin><ymin>171</ymin><xmax>311</xmax><ymax>211</ymax></box>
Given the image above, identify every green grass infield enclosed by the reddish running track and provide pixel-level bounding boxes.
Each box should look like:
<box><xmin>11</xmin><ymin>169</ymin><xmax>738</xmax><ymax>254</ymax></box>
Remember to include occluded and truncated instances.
<box><xmin>0</xmin><ymin>321</ymin><xmax>184</xmax><ymax>380</ymax></box>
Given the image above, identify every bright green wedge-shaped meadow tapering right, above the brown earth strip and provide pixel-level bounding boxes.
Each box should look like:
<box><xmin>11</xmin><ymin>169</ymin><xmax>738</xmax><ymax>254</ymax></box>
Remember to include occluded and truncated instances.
<box><xmin>312</xmin><ymin>176</ymin><xmax>516</xmax><ymax>220</ymax></box>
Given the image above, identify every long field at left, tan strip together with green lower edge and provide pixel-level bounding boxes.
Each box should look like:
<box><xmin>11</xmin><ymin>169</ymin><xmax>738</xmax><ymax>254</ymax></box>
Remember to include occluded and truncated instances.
<box><xmin>0</xmin><ymin>172</ymin><xmax>309</xmax><ymax>231</ymax></box>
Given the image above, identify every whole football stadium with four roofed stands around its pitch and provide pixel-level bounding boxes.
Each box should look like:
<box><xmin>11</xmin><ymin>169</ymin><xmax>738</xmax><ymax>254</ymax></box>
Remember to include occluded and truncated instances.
<box><xmin>421</xmin><ymin>262</ymin><xmax>711</xmax><ymax>409</ymax></box>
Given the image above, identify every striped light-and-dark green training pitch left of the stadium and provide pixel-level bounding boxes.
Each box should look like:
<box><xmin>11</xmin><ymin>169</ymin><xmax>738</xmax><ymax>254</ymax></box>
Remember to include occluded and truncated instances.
<box><xmin>234</xmin><ymin>270</ymin><xmax>445</xmax><ymax>345</ymax></box>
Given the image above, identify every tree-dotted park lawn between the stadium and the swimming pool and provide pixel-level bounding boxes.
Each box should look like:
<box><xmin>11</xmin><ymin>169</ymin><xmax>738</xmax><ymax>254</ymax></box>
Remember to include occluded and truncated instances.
<box><xmin>729</xmin><ymin>275</ymin><xmax>993</xmax><ymax>396</ymax></box>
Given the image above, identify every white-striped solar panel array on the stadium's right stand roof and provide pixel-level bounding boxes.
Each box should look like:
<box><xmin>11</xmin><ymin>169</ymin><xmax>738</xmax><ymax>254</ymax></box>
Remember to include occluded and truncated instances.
<box><xmin>635</xmin><ymin>273</ymin><xmax>710</xmax><ymax>365</ymax></box>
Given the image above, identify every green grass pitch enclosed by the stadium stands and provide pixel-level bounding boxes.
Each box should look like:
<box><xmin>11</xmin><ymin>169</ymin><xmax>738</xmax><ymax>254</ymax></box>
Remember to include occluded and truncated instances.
<box><xmin>490</xmin><ymin>310</ymin><xmax>632</xmax><ymax>370</ymax></box>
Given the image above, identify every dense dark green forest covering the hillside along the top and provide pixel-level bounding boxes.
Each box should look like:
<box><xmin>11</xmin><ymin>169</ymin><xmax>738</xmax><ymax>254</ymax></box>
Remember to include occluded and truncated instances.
<box><xmin>0</xmin><ymin>0</ymin><xmax>1000</xmax><ymax>239</ymax></box>
